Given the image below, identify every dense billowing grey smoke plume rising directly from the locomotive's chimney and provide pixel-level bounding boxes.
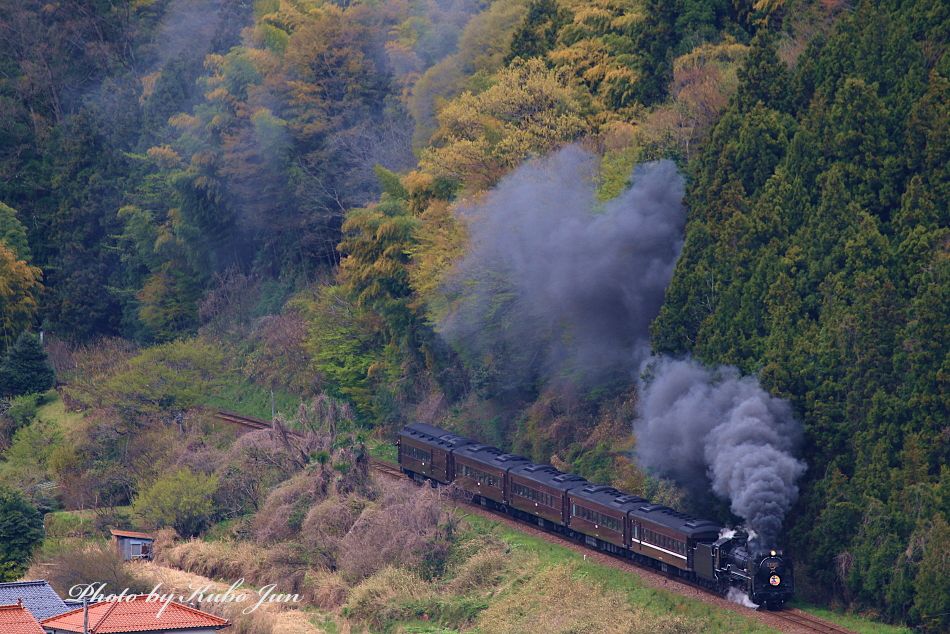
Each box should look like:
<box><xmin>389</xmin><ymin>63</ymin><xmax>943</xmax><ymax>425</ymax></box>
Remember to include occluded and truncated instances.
<box><xmin>634</xmin><ymin>357</ymin><xmax>806</xmax><ymax>547</ymax></box>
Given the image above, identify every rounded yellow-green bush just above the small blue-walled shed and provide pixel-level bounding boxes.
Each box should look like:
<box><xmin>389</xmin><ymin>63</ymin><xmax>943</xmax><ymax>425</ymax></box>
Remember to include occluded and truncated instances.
<box><xmin>132</xmin><ymin>468</ymin><xmax>218</xmax><ymax>537</ymax></box>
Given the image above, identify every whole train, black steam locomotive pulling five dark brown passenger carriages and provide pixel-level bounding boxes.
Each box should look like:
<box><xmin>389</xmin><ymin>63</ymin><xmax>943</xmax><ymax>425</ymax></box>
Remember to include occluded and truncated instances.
<box><xmin>397</xmin><ymin>423</ymin><xmax>794</xmax><ymax>609</ymax></box>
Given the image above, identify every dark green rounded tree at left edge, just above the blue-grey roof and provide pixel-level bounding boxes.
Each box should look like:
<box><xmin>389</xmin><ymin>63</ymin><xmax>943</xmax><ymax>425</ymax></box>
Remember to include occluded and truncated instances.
<box><xmin>0</xmin><ymin>485</ymin><xmax>43</xmax><ymax>581</ymax></box>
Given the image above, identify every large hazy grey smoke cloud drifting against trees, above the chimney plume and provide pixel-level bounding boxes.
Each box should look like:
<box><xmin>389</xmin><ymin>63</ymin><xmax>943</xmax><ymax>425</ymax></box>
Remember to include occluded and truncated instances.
<box><xmin>437</xmin><ymin>146</ymin><xmax>685</xmax><ymax>389</ymax></box>
